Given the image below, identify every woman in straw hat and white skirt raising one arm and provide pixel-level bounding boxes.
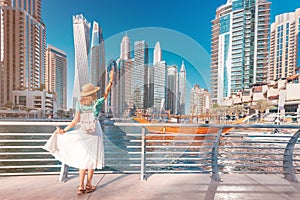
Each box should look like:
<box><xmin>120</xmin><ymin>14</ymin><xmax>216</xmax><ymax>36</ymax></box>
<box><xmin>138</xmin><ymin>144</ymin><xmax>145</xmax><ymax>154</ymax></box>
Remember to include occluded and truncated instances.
<box><xmin>44</xmin><ymin>70</ymin><xmax>113</xmax><ymax>194</ymax></box>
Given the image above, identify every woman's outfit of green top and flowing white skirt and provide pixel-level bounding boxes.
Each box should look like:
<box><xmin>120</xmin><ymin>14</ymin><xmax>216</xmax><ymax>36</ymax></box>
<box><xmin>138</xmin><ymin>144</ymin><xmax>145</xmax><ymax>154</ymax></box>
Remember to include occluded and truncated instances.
<box><xmin>43</xmin><ymin>98</ymin><xmax>104</xmax><ymax>169</ymax></box>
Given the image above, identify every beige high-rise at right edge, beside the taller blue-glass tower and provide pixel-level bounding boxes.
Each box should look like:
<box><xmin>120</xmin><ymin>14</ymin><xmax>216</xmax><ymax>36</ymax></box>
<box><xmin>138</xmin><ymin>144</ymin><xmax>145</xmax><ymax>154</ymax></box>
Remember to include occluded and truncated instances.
<box><xmin>269</xmin><ymin>8</ymin><xmax>300</xmax><ymax>81</ymax></box>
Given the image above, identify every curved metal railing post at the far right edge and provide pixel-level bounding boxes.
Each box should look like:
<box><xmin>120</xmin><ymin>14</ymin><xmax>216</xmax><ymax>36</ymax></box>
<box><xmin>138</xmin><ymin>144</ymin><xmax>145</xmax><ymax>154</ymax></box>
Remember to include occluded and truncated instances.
<box><xmin>283</xmin><ymin>130</ymin><xmax>300</xmax><ymax>182</ymax></box>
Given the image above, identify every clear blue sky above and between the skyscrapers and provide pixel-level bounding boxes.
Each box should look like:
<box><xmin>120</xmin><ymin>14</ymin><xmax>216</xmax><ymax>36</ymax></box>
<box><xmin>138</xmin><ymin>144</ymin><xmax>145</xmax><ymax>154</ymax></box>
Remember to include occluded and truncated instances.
<box><xmin>42</xmin><ymin>0</ymin><xmax>300</xmax><ymax>109</ymax></box>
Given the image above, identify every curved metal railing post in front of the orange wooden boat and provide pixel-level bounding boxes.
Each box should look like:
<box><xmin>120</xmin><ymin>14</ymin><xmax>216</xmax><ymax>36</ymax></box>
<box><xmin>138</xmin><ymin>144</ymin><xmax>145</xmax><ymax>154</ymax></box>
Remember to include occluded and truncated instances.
<box><xmin>211</xmin><ymin>128</ymin><xmax>223</xmax><ymax>181</ymax></box>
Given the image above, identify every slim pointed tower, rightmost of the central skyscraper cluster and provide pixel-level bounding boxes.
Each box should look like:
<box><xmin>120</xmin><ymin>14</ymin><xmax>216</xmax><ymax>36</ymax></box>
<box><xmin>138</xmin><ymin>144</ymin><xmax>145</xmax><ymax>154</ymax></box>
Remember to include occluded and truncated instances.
<box><xmin>178</xmin><ymin>61</ymin><xmax>186</xmax><ymax>115</ymax></box>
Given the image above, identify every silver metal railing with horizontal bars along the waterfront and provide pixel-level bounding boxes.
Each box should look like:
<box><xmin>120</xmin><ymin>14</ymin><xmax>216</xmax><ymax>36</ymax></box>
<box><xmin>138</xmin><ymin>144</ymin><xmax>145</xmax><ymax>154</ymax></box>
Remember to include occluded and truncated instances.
<box><xmin>0</xmin><ymin>122</ymin><xmax>300</xmax><ymax>182</ymax></box>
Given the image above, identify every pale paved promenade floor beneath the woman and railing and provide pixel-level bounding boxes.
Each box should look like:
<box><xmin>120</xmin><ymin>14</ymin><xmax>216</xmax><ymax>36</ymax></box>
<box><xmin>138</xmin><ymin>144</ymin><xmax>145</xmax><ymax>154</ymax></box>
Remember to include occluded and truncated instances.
<box><xmin>0</xmin><ymin>174</ymin><xmax>300</xmax><ymax>200</ymax></box>
